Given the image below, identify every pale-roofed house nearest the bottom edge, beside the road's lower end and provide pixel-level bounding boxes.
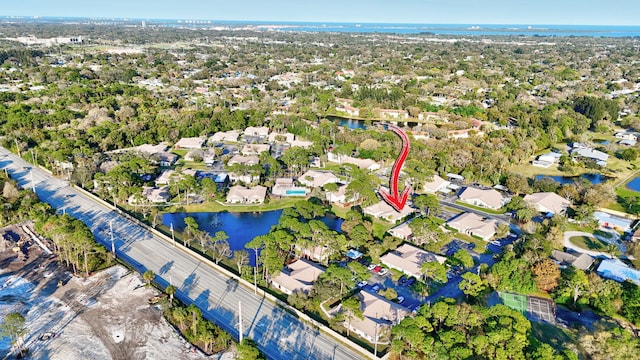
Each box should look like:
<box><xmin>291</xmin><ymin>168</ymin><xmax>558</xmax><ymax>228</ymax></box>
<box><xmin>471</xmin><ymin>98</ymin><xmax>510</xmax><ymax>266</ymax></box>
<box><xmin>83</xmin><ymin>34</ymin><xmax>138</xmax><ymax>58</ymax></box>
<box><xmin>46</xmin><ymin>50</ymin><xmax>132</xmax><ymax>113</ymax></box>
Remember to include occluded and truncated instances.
<box><xmin>344</xmin><ymin>290</ymin><xmax>409</xmax><ymax>344</ymax></box>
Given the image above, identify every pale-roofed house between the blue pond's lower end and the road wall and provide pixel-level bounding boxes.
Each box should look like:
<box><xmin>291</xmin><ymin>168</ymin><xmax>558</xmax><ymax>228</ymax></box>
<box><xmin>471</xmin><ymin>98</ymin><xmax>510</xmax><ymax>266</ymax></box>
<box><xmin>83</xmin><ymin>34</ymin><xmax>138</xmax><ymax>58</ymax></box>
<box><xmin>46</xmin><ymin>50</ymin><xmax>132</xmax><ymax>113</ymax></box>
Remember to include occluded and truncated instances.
<box><xmin>271</xmin><ymin>259</ymin><xmax>325</xmax><ymax>295</ymax></box>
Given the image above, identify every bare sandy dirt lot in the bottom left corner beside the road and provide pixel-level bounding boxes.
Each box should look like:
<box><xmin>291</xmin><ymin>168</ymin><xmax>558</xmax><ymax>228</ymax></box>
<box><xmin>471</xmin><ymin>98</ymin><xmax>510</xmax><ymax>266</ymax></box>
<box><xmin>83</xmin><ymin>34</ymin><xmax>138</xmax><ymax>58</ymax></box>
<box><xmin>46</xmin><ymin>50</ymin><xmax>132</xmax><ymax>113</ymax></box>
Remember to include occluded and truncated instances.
<box><xmin>0</xmin><ymin>228</ymin><xmax>222</xmax><ymax>360</ymax></box>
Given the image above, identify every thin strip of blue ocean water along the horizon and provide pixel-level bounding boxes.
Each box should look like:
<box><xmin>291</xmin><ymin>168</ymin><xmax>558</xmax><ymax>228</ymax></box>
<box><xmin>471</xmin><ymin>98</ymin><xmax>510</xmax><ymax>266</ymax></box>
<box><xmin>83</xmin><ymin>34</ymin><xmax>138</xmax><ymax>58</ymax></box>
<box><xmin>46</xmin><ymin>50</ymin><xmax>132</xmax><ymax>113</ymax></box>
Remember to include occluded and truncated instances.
<box><xmin>5</xmin><ymin>16</ymin><xmax>640</xmax><ymax>37</ymax></box>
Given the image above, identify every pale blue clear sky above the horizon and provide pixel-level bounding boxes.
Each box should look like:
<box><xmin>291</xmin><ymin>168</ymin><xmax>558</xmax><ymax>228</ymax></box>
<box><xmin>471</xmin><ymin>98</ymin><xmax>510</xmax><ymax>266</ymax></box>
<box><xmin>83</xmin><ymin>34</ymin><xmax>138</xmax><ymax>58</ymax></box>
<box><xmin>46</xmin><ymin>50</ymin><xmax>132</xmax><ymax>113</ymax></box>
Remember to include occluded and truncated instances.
<box><xmin>0</xmin><ymin>0</ymin><xmax>640</xmax><ymax>26</ymax></box>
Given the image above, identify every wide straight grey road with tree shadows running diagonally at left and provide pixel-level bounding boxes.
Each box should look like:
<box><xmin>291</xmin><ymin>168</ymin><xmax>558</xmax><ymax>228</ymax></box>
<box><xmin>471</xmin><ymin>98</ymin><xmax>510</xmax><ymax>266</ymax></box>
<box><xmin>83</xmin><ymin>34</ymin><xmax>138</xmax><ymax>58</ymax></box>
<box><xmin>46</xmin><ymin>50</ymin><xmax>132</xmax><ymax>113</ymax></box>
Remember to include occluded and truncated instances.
<box><xmin>0</xmin><ymin>147</ymin><xmax>363</xmax><ymax>360</ymax></box>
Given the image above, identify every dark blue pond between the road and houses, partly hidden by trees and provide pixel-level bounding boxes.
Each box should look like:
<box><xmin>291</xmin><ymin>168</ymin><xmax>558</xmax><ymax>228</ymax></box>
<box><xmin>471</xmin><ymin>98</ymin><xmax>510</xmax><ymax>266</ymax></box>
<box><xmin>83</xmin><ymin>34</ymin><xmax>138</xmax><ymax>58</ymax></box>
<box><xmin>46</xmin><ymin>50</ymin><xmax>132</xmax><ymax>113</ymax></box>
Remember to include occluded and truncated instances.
<box><xmin>162</xmin><ymin>210</ymin><xmax>343</xmax><ymax>266</ymax></box>
